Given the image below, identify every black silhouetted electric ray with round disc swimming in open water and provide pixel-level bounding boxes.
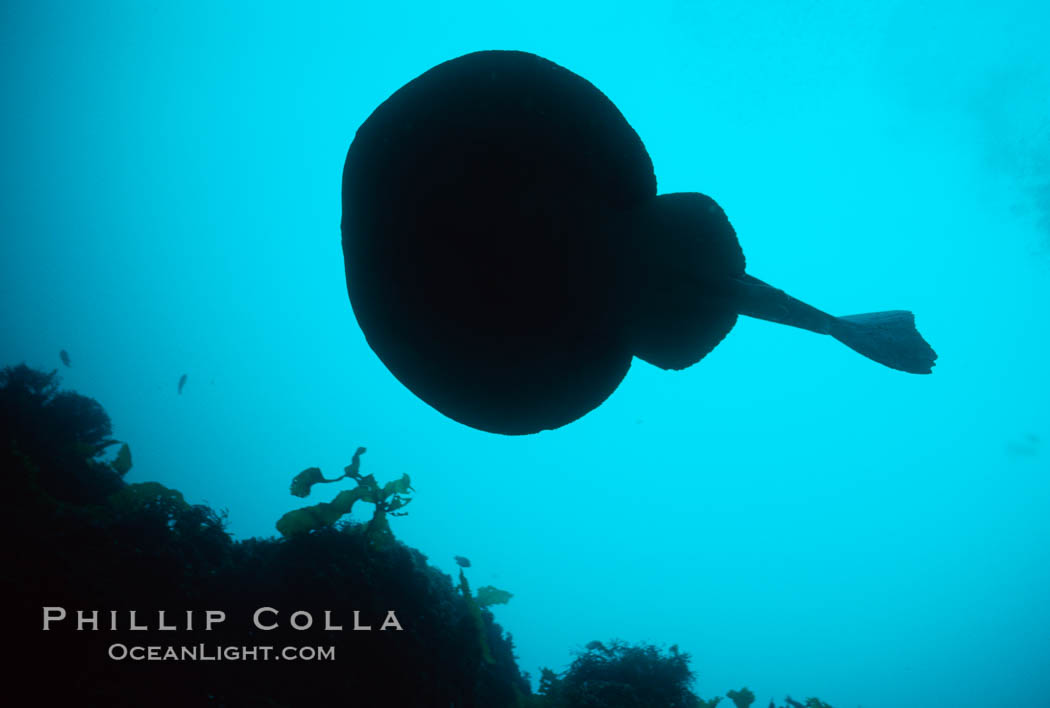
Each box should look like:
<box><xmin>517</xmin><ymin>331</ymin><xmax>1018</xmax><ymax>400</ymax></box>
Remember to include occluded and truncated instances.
<box><xmin>342</xmin><ymin>51</ymin><xmax>937</xmax><ymax>435</ymax></box>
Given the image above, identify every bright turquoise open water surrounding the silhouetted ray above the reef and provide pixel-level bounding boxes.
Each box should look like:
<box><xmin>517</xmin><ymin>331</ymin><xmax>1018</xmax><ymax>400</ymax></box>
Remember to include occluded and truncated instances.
<box><xmin>0</xmin><ymin>1</ymin><xmax>1050</xmax><ymax>708</ymax></box>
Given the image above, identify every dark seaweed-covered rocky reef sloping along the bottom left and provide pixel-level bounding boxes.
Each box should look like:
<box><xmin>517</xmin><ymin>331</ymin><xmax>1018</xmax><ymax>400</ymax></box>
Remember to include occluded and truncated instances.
<box><xmin>0</xmin><ymin>365</ymin><xmax>831</xmax><ymax>708</ymax></box>
